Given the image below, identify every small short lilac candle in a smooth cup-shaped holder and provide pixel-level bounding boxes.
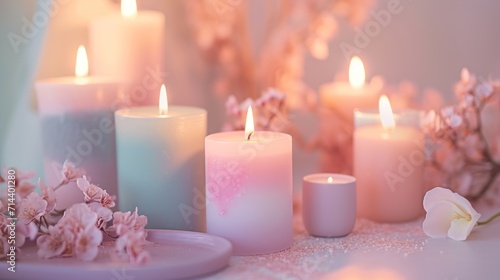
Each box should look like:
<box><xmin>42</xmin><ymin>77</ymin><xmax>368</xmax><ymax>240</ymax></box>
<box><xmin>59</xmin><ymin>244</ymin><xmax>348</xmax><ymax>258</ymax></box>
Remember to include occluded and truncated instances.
<box><xmin>302</xmin><ymin>173</ymin><xmax>356</xmax><ymax>237</ymax></box>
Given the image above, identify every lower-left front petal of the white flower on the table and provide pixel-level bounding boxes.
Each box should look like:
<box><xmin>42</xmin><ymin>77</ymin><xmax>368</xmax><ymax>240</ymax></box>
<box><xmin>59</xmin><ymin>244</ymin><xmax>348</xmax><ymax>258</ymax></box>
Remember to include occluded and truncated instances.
<box><xmin>422</xmin><ymin>200</ymin><xmax>456</xmax><ymax>238</ymax></box>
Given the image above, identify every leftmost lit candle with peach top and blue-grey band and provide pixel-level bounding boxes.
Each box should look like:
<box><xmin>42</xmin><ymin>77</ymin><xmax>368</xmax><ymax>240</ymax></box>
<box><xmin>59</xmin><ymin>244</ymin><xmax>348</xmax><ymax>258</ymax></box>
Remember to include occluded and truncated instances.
<box><xmin>35</xmin><ymin>46</ymin><xmax>124</xmax><ymax>209</ymax></box>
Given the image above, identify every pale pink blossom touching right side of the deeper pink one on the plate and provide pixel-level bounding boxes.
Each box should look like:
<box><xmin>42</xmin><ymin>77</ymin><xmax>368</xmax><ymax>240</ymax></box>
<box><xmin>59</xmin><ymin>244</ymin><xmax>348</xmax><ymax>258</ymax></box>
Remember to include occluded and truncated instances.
<box><xmin>75</xmin><ymin>224</ymin><xmax>102</xmax><ymax>261</ymax></box>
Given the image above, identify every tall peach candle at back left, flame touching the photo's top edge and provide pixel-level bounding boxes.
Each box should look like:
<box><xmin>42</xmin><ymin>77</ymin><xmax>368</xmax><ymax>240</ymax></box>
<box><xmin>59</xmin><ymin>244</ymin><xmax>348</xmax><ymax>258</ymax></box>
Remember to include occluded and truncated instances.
<box><xmin>89</xmin><ymin>0</ymin><xmax>165</xmax><ymax>105</ymax></box>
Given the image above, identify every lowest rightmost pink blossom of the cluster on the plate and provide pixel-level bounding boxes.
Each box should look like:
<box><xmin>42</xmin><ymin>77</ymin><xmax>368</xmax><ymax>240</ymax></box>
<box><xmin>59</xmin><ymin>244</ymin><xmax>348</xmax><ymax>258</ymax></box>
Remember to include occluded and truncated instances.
<box><xmin>115</xmin><ymin>230</ymin><xmax>150</xmax><ymax>264</ymax></box>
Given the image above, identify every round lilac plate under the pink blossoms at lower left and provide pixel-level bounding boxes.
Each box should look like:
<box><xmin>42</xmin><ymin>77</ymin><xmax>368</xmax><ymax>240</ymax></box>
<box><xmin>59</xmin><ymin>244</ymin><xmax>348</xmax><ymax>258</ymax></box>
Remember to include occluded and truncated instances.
<box><xmin>0</xmin><ymin>230</ymin><xmax>232</xmax><ymax>280</ymax></box>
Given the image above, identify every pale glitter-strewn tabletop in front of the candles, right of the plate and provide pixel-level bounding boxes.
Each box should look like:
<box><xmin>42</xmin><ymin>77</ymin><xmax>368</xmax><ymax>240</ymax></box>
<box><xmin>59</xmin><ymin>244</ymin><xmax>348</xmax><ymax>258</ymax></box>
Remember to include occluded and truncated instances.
<box><xmin>204</xmin><ymin>198</ymin><xmax>500</xmax><ymax>280</ymax></box>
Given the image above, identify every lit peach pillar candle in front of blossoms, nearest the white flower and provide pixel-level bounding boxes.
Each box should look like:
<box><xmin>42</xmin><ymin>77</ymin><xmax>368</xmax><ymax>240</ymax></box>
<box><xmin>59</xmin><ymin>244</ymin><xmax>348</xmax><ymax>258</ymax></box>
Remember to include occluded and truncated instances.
<box><xmin>354</xmin><ymin>96</ymin><xmax>425</xmax><ymax>222</ymax></box>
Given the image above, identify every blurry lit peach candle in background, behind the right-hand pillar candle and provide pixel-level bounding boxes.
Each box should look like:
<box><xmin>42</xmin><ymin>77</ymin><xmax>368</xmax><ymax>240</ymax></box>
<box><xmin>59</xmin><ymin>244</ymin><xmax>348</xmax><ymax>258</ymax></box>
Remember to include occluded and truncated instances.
<box><xmin>320</xmin><ymin>56</ymin><xmax>383</xmax><ymax>124</ymax></box>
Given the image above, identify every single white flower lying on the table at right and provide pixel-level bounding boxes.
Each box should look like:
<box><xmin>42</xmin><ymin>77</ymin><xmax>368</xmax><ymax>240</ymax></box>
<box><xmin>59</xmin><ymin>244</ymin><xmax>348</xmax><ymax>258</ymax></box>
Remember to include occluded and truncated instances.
<box><xmin>422</xmin><ymin>187</ymin><xmax>481</xmax><ymax>240</ymax></box>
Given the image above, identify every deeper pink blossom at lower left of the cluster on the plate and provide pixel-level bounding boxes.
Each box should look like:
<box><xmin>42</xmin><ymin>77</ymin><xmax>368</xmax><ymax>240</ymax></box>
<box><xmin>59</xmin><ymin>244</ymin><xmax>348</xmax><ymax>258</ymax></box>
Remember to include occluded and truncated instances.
<box><xmin>36</xmin><ymin>224</ymin><xmax>75</xmax><ymax>259</ymax></box>
